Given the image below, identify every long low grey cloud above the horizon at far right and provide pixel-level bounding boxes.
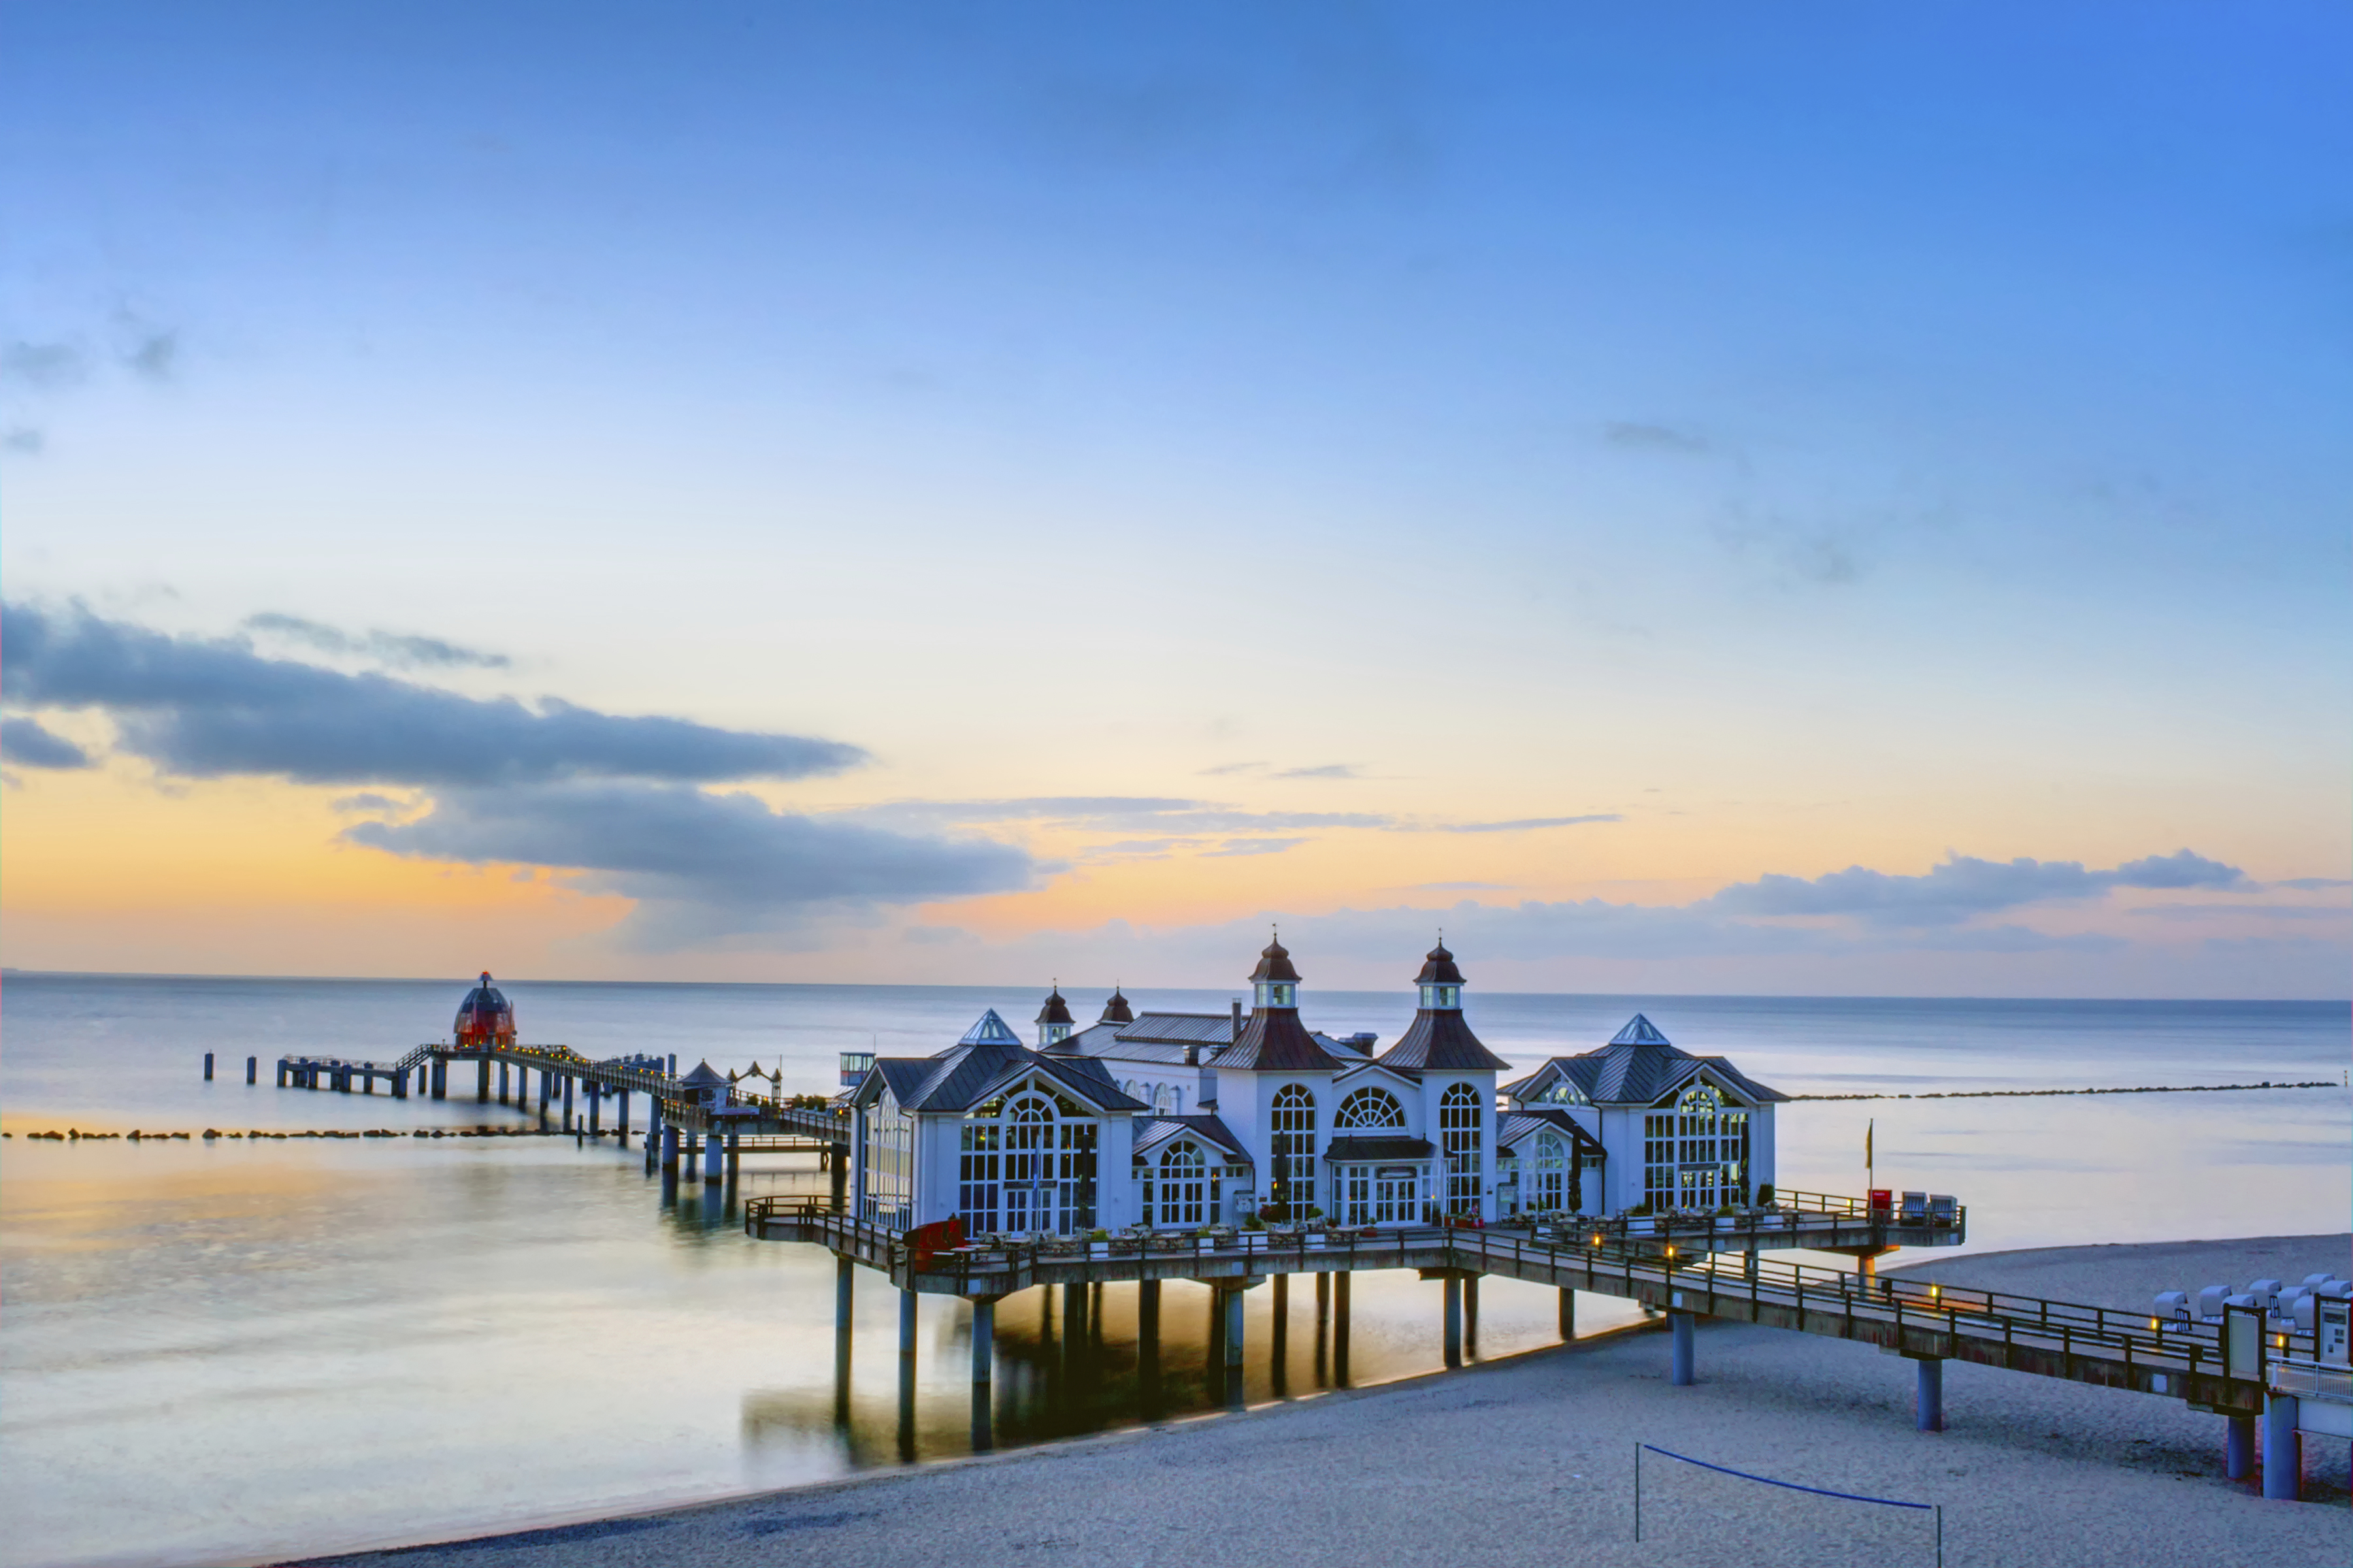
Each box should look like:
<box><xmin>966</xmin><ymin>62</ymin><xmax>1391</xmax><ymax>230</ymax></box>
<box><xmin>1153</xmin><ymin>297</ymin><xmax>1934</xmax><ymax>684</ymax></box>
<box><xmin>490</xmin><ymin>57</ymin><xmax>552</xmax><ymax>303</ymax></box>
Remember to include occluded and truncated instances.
<box><xmin>1699</xmin><ymin>850</ymin><xmax>2245</xmax><ymax>930</ymax></box>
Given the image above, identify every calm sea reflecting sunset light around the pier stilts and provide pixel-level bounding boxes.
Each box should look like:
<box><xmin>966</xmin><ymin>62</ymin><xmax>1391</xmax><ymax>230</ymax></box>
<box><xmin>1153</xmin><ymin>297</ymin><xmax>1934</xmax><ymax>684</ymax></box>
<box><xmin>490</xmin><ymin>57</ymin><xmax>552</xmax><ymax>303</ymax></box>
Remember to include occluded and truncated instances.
<box><xmin>0</xmin><ymin>975</ymin><xmax>2353</xmax><ymax>1565</ymax></box>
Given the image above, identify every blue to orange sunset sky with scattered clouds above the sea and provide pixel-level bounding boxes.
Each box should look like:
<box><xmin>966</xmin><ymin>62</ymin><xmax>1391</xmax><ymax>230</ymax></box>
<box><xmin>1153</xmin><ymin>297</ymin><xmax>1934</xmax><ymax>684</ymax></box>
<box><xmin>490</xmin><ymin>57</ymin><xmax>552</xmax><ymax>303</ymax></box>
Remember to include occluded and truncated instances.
<box><xmin>0</xmin><ymin>0</ymin><xmax>2353</xmax><ymax>998</ymax></box>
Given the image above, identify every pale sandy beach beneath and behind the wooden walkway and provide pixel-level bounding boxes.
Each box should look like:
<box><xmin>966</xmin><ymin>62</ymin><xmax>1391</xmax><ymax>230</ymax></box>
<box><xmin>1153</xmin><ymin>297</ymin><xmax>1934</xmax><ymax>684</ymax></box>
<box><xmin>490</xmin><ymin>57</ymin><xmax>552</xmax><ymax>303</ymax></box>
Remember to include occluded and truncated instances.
<box><xmin>316</xmin><ymin>1236</ymin><xmax>2353</xmax><ymax>1568</ymax></box>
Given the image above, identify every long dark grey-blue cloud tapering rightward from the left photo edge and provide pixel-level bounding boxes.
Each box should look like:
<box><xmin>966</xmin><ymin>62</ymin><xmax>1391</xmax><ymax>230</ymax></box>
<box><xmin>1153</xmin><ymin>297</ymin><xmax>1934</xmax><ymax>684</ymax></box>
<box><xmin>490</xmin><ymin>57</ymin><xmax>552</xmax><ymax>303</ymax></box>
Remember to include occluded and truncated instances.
<box><xmin>0</xmin><ymin>605</ymin><xmax>866</xmax><ymax>787</ymax></box>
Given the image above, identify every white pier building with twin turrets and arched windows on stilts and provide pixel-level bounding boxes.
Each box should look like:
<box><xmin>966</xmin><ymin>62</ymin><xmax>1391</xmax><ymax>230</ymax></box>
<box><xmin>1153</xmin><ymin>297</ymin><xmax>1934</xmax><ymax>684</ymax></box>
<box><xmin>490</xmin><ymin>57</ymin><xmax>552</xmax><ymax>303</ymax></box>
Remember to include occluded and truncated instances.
<box><xmin>847</xmin><ymin>939</ymin><xmax>1784</xmax><ymax>1236</ymax></box>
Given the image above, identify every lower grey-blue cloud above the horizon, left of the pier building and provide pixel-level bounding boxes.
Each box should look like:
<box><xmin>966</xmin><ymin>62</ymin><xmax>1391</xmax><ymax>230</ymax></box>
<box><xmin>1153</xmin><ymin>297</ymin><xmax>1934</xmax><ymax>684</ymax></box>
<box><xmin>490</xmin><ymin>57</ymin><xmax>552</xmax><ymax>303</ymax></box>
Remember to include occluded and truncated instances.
<box><xmin>344</xmin><ymin>781</ymin><xmax>1047</xmax><ymax>951</ymax></box>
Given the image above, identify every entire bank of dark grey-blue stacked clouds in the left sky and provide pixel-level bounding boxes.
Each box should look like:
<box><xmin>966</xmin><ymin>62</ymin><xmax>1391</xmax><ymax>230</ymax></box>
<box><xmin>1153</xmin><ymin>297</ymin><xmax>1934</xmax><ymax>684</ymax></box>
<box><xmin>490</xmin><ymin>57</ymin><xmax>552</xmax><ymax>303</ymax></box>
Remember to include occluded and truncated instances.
<box><xmin>0</xmin><ymin>605</ymin><xmax>1038</xmax><ymax>947</ymax></box>
